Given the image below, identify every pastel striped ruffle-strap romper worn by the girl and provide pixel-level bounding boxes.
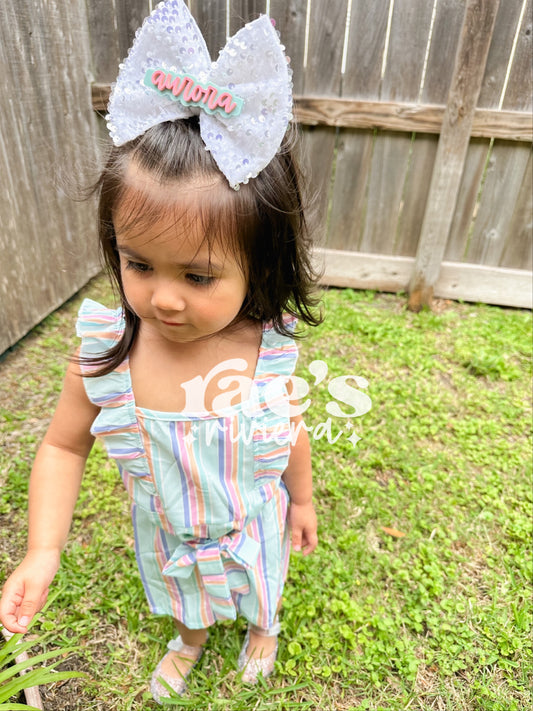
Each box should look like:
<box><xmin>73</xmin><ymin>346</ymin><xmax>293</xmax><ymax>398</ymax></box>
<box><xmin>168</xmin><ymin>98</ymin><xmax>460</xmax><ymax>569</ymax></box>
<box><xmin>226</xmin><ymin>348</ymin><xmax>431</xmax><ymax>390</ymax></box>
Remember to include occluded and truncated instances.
<box><xmin>77</xmin><ymin>299</ymin><xmax>297</xmax><ymax>629</ymax></box>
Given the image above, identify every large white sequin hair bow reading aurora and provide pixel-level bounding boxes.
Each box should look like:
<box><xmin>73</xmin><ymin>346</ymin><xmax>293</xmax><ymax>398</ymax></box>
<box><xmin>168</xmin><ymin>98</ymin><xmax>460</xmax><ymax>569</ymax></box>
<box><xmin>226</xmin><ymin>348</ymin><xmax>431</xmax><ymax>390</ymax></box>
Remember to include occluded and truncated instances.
<box><xmin>106</xmin><ymin>0</ymin><xmax>292</xmax><ymax>189</ymax></box>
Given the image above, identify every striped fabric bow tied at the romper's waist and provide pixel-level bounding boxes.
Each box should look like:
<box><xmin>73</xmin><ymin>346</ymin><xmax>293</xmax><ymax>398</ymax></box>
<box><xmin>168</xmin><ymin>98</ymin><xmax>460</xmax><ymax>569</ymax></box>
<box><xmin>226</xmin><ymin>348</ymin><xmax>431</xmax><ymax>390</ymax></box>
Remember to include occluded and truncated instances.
<box><xmin>163</xmin><ymin>531</ymin><xmax>260</xmax><ymax>619</ymax></box>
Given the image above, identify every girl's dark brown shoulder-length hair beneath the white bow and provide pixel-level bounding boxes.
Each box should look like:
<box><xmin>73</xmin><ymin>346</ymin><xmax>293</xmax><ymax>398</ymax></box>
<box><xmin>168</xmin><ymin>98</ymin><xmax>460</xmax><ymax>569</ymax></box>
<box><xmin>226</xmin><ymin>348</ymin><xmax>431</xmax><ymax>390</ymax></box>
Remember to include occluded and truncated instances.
<box><xmin>85</xmin><ymin>117</ymin><xmax>322</xmax><ymax>376</ymax></box>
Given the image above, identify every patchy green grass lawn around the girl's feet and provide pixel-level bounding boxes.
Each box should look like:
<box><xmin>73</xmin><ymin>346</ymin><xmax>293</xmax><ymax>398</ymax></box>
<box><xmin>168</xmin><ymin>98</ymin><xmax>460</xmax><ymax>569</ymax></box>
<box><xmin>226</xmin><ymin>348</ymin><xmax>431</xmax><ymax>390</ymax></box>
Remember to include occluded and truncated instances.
<box><xmin>0</xmin><ymin>280</ymin><xmax>532</xmax><ymax>711</ymax></box>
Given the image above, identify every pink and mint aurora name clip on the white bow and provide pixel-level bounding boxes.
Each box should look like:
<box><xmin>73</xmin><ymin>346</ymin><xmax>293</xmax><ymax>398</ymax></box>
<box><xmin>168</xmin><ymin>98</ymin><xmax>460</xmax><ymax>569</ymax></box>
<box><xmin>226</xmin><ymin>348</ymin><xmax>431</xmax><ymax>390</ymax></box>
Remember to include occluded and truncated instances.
<box><xmin>143</xmin><ymin>69</ymin><xmax>244</xmax><ymax>116</ymax></box>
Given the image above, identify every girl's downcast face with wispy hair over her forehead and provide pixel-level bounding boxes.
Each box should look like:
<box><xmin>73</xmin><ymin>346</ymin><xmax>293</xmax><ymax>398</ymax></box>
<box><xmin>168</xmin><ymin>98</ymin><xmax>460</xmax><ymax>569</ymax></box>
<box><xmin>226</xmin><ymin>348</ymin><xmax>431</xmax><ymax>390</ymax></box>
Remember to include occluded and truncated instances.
<box><xmin>113</xmin><ymin>162</ymin><xmax>248</xmax><ymax>343</ymax></box>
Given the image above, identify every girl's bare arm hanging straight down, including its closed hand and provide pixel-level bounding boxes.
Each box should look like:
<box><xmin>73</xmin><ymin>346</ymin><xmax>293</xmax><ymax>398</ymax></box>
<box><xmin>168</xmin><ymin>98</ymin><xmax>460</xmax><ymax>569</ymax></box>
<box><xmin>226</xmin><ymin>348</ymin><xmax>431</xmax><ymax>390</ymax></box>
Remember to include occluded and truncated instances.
<box><xmin>282</xmin><ymin>415</ymin><xmax>318</xmax><ymax>555</ymax></box>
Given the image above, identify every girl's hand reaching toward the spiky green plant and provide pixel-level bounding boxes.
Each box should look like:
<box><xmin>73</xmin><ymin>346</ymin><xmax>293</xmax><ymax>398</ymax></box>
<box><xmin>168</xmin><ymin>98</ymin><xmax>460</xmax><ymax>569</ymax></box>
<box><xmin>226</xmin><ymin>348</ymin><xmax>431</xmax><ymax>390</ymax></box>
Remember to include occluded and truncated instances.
<box><xmin>0</xmin><ymin>550</ymin><xmax>59</xmax><ymax>633</ymax></box>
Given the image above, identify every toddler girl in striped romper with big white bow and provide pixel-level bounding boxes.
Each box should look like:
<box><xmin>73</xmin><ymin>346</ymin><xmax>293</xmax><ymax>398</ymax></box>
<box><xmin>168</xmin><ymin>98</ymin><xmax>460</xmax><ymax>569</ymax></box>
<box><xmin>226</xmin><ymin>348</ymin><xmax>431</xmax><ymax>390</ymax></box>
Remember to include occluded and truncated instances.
<box><xmin>0</xmin><ymin>0</ymin><xmax>318</xmax><ymax>701</ymax></box>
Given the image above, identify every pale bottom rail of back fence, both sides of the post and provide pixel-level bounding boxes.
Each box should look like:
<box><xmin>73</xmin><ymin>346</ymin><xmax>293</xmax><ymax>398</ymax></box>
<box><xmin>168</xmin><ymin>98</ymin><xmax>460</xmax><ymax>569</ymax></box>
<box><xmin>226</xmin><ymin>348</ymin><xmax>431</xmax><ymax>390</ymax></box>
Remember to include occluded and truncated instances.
<box><xmin>314</xmin><ymin>249</ymin><xmax>533</xmax><ymax>309</ymax></box>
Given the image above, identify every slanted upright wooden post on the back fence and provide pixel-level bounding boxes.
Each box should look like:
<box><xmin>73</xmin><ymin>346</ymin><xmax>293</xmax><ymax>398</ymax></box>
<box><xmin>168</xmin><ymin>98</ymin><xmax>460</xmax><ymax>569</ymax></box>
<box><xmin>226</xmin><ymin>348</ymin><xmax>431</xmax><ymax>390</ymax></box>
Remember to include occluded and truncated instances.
<box><xmin>408</xmin><ymin>0</ymin><xmax>500</xmax><ymax>311</ymax></box>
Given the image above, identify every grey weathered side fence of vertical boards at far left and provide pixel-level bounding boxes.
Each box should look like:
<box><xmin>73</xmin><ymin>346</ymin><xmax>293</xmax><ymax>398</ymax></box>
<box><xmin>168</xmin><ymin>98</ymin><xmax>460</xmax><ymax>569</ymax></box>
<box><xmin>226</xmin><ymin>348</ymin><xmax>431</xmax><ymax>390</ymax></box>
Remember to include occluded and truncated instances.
<box><xmin>0</xmin><ymin>0</ymin><xmax>99</xmax><ymax>352</ymax></box>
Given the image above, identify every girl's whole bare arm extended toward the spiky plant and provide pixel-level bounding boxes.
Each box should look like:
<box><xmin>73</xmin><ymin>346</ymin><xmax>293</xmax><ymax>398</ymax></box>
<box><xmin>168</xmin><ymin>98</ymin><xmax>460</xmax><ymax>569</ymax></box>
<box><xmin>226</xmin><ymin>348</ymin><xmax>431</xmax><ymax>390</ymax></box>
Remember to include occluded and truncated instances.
<box><xmin>0</xmin><ymin>365</ymin><xmax>99</xmax><ymax>632</ymax></box>
